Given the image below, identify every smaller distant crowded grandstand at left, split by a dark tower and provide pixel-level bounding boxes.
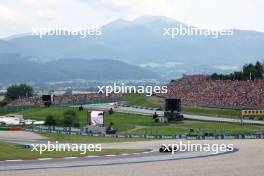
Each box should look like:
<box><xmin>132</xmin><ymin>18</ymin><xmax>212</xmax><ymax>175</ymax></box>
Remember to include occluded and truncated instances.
<box><xmin>9</xmin><ymin>93</ymin><xmax>121</xmax><ymax>106</ymax></box>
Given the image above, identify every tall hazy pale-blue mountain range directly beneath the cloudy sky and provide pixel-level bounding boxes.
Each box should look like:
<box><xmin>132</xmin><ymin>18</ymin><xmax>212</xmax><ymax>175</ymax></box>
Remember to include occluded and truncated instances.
<box><xmin>0</xmin><ymin>16</ymin><xmax>264</xmax><ymax>78</ymax></box>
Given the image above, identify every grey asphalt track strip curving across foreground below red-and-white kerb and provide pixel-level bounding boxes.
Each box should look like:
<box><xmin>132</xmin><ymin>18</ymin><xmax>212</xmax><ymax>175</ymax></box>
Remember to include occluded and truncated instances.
<box><xmin>0</xmin><ymin>148</ymin><xmax>235</xmax><ymax>171</ymax></box>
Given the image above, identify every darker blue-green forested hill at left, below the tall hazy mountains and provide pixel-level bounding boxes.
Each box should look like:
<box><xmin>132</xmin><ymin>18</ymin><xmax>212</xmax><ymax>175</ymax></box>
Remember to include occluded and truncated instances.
<box><xmin>0</xmin><ymin>54</ymin><xmax>159</xmax><ymax>84</ymax></box>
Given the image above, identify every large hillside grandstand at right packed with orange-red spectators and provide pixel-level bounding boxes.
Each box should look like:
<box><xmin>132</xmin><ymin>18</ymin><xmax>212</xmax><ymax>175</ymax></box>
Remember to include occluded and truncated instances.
<box><xmin>165</xmin><ymin>75</ymin><xmax>264</xmax><ymax>108</ymax></box>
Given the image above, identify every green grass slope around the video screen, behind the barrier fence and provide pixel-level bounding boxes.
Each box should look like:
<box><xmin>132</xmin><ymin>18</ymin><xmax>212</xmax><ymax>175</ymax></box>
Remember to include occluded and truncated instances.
<box><xmin>13</xmin><ymin>107</ymin><xmax>264</xmax><ymax>136</ymax></box>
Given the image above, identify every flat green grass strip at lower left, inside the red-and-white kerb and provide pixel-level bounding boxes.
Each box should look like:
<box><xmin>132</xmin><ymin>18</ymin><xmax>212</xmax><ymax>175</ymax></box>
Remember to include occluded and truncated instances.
<box><xmin>0</xmin><ymin>142</ymin><xmax>142</xmax><ymax>160</ymax></box>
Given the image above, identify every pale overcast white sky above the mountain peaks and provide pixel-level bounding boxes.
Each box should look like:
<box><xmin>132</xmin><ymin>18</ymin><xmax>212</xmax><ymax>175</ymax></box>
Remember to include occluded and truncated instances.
<box><xmin>0</xmin><ymin>0</ymin><xmax>264</xmax><ymax>37</ymax></box>
